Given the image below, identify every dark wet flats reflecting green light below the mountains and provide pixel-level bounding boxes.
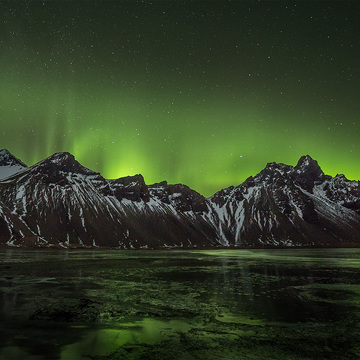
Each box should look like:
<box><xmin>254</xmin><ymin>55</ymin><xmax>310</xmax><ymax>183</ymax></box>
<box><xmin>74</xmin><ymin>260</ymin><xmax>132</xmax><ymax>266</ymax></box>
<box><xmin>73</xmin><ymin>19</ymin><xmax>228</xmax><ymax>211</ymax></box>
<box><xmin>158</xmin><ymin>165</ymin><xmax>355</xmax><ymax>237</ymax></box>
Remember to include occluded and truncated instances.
<box><xmin>0</xmin><ymin>249</ymin><xmax>360</xmax><ymax>360</ymax></box>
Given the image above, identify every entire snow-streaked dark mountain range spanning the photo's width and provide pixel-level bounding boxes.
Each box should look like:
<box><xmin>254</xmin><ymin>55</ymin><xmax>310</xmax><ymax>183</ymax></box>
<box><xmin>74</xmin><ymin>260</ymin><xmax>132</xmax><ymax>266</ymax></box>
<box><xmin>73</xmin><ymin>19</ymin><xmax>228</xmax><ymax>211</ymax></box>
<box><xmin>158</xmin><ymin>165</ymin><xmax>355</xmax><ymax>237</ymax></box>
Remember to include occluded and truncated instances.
<box><xmin>0</xmin><ymin>149</ymin><xmax>360</xmax><ymax>249</ymax></box>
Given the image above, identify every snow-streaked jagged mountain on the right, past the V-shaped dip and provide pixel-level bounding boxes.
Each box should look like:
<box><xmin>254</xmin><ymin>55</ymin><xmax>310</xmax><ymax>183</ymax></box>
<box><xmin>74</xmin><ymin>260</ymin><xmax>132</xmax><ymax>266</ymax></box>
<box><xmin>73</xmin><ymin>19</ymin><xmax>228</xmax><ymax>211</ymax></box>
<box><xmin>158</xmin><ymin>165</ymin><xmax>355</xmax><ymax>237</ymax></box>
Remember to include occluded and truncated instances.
<box><xmin>210</xmin><ymin>156</ymin><xmax>360</xmax><ymax>246</ymax></box>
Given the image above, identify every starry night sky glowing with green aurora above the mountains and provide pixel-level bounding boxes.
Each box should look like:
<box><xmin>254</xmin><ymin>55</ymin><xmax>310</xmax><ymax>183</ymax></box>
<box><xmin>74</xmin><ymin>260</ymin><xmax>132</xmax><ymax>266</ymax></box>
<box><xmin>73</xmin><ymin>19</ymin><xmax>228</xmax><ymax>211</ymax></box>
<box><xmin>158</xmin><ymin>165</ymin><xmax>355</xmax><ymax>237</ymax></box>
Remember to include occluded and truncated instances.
<box><xmin>0</xmin><ymin>0</ymin><xmax>360</xmax><ymax>196</ymax></box>
